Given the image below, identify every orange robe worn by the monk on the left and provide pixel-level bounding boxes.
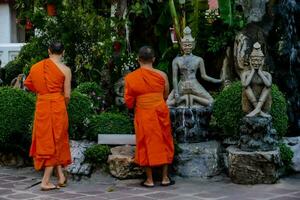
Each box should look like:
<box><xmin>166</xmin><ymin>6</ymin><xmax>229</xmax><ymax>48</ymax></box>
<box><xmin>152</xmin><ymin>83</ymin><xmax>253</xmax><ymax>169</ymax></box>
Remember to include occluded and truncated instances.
<box><xmin>24</xmin><ymin>59</ymin><xmax>71</xmax><ymax>170</ymax></box>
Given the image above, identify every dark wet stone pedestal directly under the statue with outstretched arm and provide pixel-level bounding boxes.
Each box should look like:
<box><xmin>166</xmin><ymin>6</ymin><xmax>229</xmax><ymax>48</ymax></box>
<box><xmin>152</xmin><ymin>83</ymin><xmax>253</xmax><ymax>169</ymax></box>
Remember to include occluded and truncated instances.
<box><xmin>170</xmin><ymin>106</ymin><xmax>212</xmax><ymax>143</ymax></box>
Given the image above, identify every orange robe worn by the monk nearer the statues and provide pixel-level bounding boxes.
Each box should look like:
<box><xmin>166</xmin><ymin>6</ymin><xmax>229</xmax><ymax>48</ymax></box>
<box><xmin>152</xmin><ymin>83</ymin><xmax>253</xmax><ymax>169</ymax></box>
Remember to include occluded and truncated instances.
<box><xmin>124</xmin><ymin>68</ymin><xmax>174</xmax><ymax>166</ymax></box>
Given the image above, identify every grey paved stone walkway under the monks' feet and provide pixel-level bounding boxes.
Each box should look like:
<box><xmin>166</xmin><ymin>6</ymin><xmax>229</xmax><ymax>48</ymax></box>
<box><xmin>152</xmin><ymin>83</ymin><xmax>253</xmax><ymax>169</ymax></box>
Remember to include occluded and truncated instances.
<box><xmin>0</xmin><ymin>167</ymin><xmax>300</xmax><ymax>200</ymax></box>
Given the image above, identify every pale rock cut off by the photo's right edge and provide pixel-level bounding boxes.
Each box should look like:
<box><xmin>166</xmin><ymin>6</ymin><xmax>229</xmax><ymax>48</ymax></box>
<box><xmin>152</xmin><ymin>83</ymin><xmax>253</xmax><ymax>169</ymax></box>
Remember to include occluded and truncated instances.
<box><xmin>284</xmin><ymin>137</ymin><xmax>300</xmax><ymax>172</ymax></box>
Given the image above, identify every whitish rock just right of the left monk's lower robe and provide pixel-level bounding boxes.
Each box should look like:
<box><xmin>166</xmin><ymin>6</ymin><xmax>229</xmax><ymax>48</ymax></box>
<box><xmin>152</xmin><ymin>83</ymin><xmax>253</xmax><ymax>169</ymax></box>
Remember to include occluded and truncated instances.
<box><xmin>66</xmin><ymin>140</ymin><xmax>95</xmax><ymax>175</ymax></box>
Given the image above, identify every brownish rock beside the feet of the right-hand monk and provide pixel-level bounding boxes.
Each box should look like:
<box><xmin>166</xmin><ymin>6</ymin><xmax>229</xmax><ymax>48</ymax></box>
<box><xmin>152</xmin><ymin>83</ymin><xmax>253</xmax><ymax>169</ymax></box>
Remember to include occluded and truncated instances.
<box><xmin>107</xmin><ymin>145</ymin><xmax>144</xmax><ymax>179</ymax></box>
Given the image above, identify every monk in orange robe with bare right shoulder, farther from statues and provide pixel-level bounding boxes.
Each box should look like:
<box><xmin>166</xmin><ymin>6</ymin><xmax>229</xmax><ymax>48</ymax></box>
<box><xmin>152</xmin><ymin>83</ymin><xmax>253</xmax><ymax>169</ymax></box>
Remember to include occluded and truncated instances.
<box><xmin>24</xmin><ymin>42</ymin><xmax>71</xmax><ymax>190</ymax></box>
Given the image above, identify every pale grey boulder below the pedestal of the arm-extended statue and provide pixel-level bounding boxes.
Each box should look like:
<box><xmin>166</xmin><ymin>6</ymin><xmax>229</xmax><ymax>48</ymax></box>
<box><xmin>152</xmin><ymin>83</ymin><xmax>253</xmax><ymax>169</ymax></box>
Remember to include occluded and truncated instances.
<box><xmin>175</xmin><ymin>141</ymin><xmax>222</xmax><ymax>178</ymax></box>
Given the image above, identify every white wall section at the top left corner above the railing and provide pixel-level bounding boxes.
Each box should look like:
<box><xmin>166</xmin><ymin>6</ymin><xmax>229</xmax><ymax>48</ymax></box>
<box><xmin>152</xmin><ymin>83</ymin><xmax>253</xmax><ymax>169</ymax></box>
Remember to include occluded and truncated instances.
<box><xmin>0</xmin><ymin>4</ymin><xmax>11</xmax><ymax>43</ymax></box>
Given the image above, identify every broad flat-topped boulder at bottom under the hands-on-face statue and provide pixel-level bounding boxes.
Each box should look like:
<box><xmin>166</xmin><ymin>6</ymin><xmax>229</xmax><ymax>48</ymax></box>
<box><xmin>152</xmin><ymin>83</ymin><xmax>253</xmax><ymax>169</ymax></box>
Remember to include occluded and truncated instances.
<box><xmin>226</xmin><ymin>146</ymin><xmax>281</xmax><ymax>184</ymax></box>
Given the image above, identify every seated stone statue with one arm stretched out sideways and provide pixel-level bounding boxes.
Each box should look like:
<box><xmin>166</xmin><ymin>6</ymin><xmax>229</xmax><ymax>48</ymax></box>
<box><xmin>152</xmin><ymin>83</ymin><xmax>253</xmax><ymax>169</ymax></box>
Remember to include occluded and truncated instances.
<box><xmin>167</xmin><ymin>27</ymin><xmax>222</xmax><ymax>107</ymax></box>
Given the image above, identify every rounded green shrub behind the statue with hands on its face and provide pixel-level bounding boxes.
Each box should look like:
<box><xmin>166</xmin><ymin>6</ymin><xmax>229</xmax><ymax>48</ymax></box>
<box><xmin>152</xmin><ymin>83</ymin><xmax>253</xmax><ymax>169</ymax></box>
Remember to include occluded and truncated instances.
<box><xmin>213</xmin><ymin>82</ymin><xmax>288</xmax><ymax>137</ymax></box>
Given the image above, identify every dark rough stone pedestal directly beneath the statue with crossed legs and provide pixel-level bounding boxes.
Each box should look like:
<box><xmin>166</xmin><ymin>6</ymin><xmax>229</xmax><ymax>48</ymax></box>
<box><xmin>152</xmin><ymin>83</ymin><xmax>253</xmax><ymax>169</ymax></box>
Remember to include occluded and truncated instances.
<box><xmin>239</xmin><ymin>116</ymin><xmax>278</xmax><ymax>151</ymax></box>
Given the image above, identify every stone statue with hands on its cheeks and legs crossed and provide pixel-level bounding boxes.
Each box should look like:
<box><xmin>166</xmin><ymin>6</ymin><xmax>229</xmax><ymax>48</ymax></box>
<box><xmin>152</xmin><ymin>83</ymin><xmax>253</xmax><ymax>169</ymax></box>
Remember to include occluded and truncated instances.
<box><xmin>241</xmin><ymin>42</ymin><xmax>272</xmax><ymax>117</ymax></box>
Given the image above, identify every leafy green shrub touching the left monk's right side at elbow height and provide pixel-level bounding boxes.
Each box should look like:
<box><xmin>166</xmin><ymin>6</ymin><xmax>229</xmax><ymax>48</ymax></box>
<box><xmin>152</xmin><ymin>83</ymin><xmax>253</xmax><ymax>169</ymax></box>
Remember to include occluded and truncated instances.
<box><xmin>68</xmin><ymin>92</ymin><xmax>94</xmax><ymax>140</ymax></box>
